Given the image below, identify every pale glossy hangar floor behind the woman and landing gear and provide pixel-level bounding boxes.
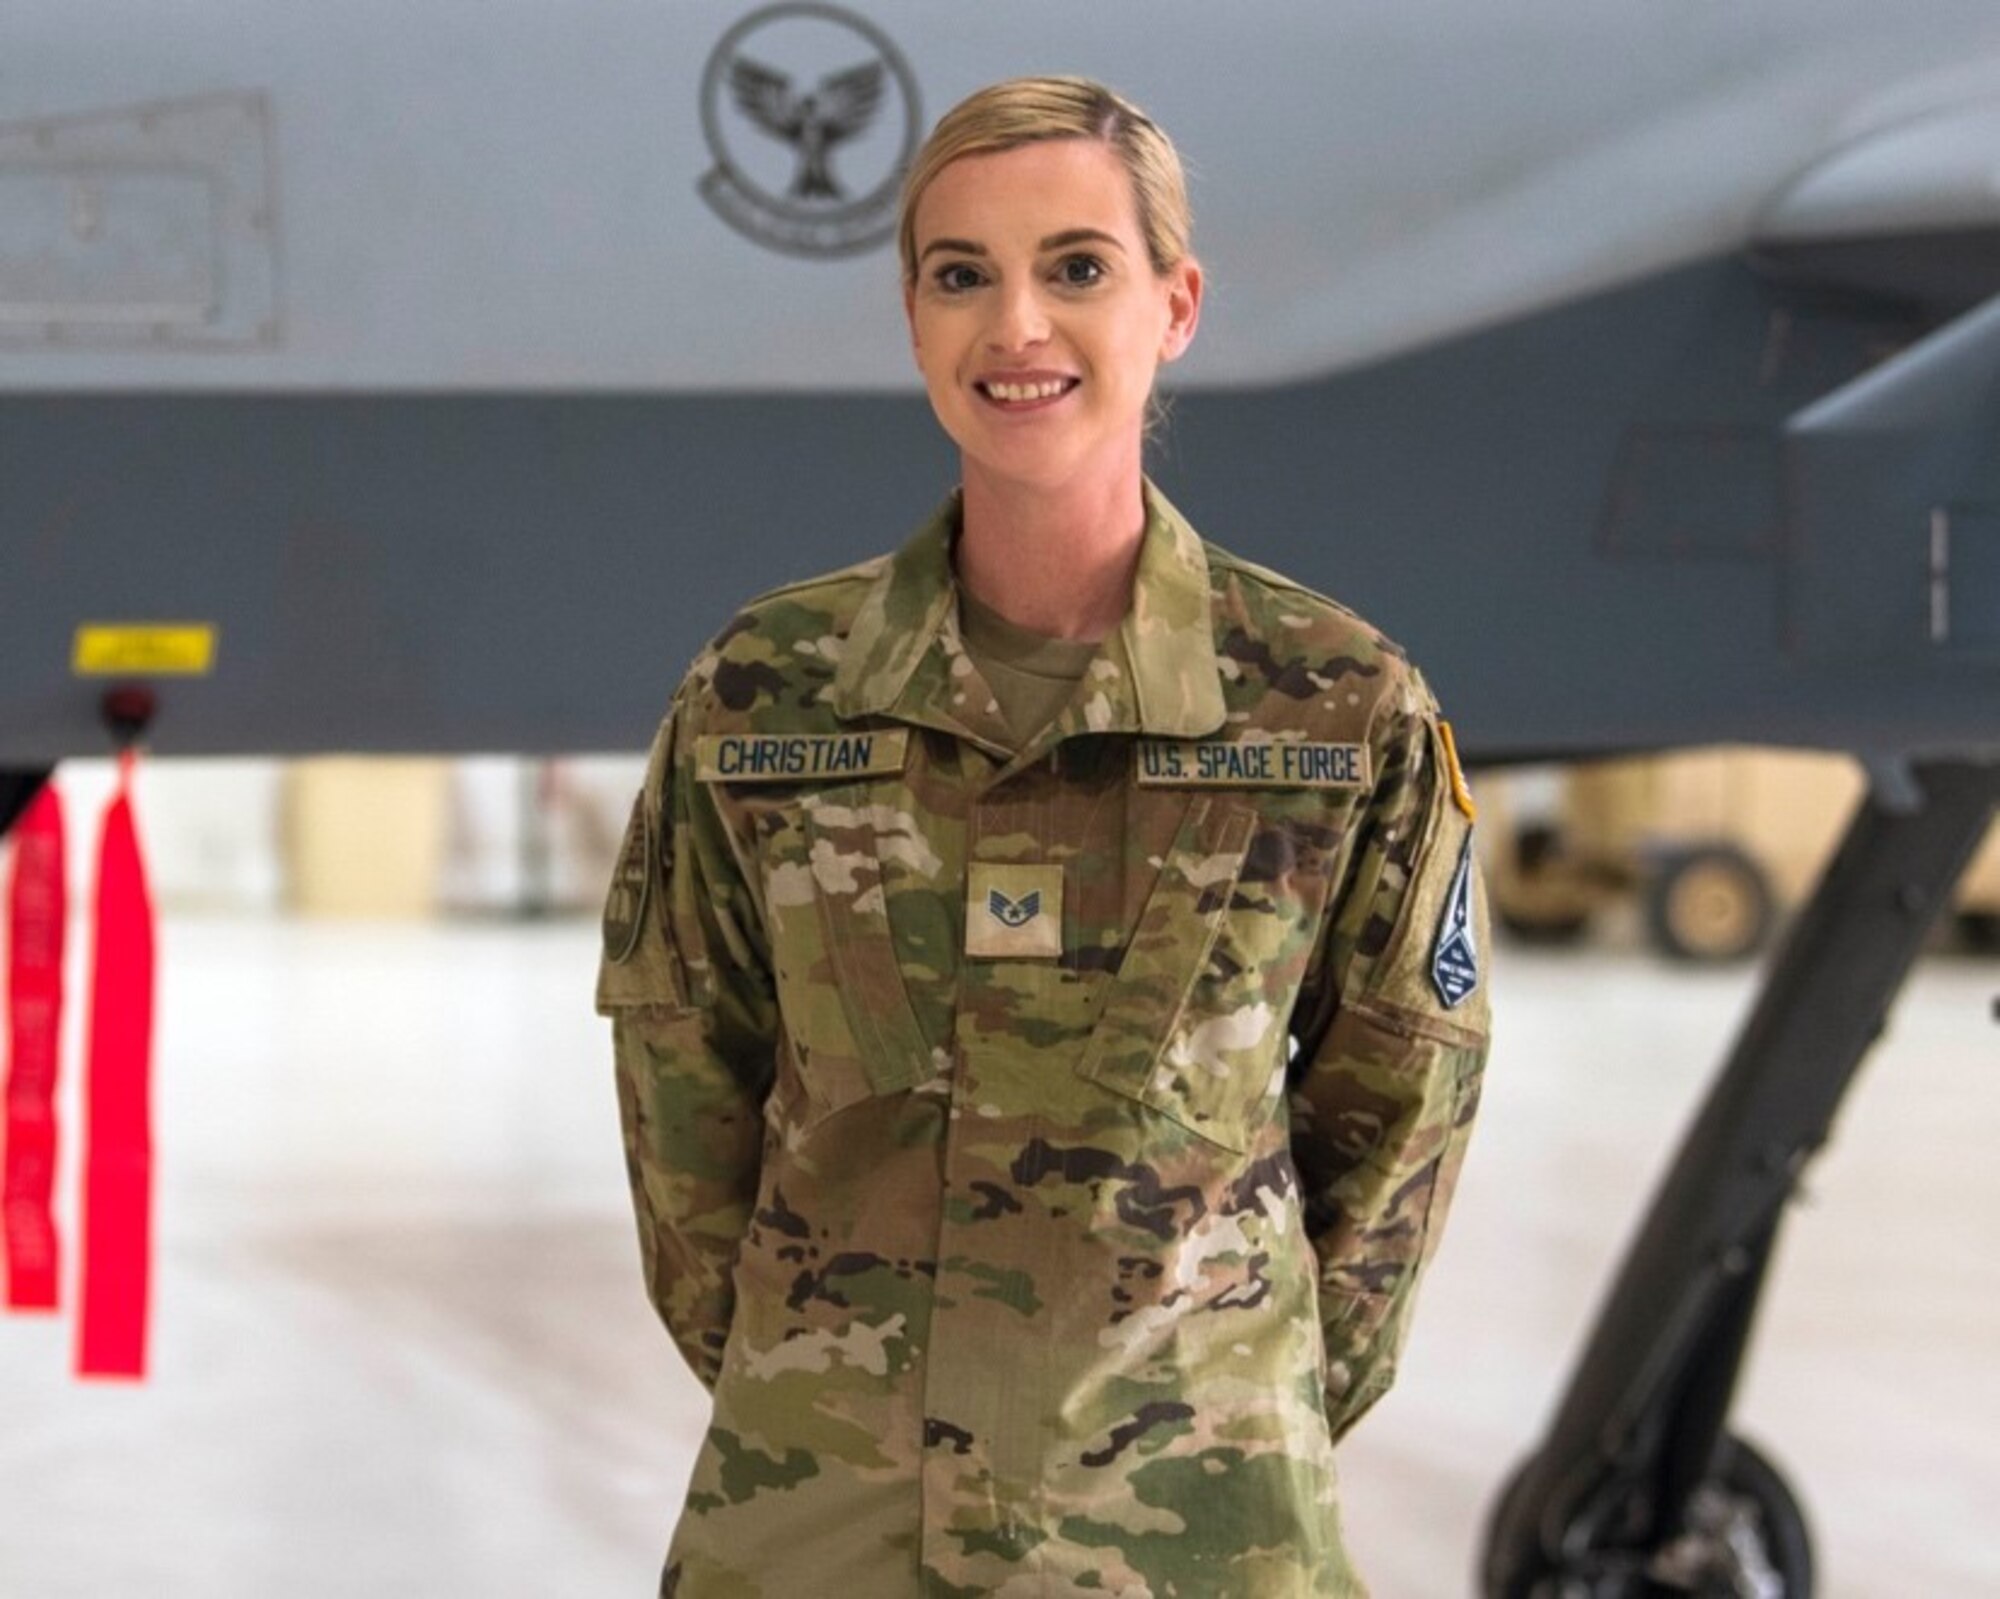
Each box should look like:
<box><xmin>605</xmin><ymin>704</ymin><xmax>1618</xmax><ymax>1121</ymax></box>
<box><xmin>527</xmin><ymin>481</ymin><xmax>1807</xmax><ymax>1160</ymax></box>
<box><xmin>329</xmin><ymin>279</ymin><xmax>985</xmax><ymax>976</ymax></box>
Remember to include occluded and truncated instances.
<box><xmin>0</xmin><ymin>917</ymin><xmax>2000</xmax><ymax>1599</ymax></box>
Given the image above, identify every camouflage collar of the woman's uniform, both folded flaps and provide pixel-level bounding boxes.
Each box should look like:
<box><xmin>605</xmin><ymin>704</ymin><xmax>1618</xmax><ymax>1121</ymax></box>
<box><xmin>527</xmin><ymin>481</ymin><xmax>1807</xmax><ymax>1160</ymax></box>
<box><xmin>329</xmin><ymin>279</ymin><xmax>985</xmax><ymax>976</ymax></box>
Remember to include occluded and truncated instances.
<box><xmin>832</xmin><ymin>480</ymin><xmax>1224</xmax><ymax>744</ymax></box>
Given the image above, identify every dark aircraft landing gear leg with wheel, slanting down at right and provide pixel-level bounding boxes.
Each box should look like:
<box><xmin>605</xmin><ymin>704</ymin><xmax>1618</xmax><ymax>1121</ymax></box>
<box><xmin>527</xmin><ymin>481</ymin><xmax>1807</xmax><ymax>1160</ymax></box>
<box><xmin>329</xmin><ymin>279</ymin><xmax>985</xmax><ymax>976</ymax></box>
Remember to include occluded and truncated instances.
<box><xmin>1480</xmin><ymin>762</ymin><xmax>2000</xmax><ymax>1599</ymax></box>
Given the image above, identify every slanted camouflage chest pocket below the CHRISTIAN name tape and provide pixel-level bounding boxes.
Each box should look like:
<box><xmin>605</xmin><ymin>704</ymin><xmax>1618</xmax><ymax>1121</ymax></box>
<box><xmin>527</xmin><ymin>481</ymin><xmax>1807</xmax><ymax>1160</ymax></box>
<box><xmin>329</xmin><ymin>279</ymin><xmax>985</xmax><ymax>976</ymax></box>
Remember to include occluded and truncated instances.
<box><xmin>764</xmin><ymin>784</ymin><xmax>936</xmax><ymax>1115</ymax></box>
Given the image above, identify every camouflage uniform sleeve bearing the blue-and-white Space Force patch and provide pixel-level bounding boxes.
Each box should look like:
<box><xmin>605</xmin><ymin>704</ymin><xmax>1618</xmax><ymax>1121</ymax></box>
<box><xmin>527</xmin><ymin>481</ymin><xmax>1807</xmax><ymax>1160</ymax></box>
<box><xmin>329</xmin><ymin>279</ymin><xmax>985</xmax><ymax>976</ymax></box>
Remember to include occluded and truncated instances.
<box><xmin>1290</xmin><ymin>674</ymin><xmax>1490</xmax><ymax>1437</ymax></box>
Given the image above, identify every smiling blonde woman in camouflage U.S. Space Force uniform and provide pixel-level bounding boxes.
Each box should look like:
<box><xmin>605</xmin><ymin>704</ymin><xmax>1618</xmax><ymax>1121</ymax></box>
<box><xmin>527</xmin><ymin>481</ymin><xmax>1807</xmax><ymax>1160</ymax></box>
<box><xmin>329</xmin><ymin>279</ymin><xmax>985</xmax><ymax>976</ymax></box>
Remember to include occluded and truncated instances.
<box><xmin>598</xmin><ymin>78</ymin><xmax>1488</xmax><ymax>1599</ymax></box>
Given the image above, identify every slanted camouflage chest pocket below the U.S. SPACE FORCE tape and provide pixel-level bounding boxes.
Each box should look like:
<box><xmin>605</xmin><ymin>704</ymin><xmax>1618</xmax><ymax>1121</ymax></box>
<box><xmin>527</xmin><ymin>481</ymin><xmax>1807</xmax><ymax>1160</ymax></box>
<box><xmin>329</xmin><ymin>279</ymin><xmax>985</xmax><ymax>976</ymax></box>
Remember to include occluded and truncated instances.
<box><xmin>1076</xmin><ymin>796</ymin><xmax>1298</xmax><ymax>1153</ymax></box>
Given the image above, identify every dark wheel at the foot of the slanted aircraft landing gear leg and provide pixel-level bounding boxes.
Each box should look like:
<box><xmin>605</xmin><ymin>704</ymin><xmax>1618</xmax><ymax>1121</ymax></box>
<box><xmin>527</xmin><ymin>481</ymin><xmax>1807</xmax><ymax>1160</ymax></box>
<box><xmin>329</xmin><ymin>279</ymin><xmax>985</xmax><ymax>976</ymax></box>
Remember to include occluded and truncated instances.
<box><xmin>1648</xmin><ymin>1437</ymin><xmax>1812</xmax><ymax>1599</ymax></box>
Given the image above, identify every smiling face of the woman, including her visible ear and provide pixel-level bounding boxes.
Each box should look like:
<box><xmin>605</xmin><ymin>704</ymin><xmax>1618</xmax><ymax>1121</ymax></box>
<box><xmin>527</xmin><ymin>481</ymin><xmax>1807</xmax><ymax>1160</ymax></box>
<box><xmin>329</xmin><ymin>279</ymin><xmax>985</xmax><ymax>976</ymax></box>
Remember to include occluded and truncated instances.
<box><xmin>904</xmin><ymin>138</ymin><xmax>1202</xmax><ymax>505</ymax></box>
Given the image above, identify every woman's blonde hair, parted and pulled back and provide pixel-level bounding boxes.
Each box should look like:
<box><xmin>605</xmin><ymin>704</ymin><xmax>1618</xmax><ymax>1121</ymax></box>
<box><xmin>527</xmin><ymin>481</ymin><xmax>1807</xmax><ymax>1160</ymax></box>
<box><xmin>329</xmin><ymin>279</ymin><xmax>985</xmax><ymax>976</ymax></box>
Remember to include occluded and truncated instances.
<box><xmin>896</xmin><ymin>78</ymin><xmax>1194</xmax><ymax>284</ymax></box>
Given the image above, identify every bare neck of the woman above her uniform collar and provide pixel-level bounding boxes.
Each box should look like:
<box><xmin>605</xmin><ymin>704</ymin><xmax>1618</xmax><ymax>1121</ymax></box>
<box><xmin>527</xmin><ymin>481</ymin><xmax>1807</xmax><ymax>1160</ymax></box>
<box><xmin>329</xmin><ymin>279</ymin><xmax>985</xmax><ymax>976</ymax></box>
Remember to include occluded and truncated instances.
<box><xmin>958</xmin><ymin>462</ymin><xmax>1146</xmax><ymax>642</ymax></box>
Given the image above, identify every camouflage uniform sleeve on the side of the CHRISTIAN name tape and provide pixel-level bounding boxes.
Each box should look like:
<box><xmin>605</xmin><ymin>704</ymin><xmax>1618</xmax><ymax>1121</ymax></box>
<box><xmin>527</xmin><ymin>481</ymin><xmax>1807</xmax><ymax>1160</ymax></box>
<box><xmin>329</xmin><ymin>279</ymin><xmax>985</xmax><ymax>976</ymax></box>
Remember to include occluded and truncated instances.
<box><xmin>596</xmin><ymin>702</ymin><xmax>776</xmax><ymax>1389</ymax></box>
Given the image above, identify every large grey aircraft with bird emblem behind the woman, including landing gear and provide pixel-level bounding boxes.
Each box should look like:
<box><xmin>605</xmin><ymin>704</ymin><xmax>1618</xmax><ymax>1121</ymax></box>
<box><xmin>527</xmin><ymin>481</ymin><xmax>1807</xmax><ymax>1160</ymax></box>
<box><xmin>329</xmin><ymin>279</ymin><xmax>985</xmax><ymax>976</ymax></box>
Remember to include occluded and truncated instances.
<box><xmin>0</xmin><ymin>0</ymin><xmax>2000</xmax><ymax>1599</ymax></box>
